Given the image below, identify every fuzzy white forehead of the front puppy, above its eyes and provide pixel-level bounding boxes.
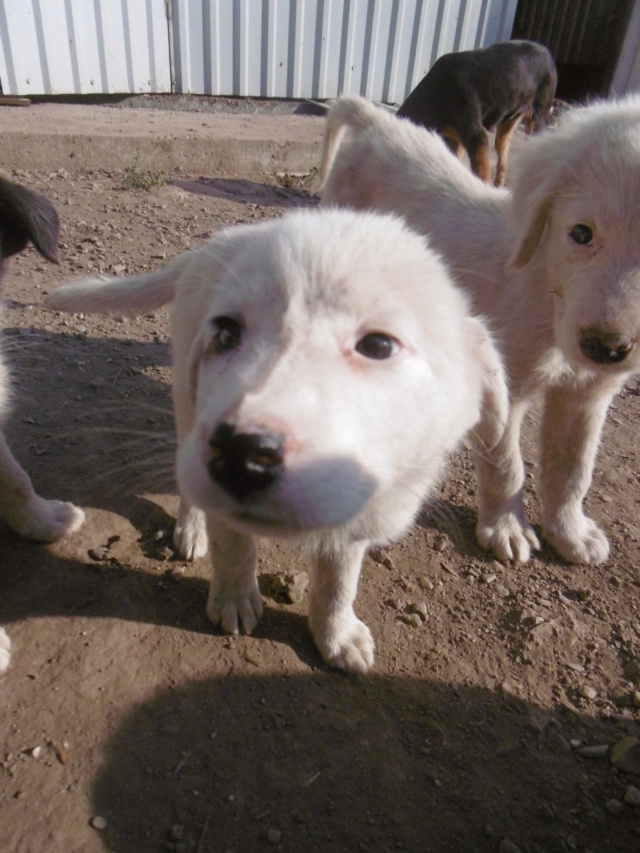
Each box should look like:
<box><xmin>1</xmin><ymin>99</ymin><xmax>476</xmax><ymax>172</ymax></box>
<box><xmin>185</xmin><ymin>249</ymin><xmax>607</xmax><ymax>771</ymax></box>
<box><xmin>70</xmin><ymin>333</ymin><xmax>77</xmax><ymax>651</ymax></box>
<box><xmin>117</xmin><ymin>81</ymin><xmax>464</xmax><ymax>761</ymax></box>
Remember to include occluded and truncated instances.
<box><xmin>195</xmin><ymin>209</ymin><xmax>467</xmax><ymax>339</ymax></box>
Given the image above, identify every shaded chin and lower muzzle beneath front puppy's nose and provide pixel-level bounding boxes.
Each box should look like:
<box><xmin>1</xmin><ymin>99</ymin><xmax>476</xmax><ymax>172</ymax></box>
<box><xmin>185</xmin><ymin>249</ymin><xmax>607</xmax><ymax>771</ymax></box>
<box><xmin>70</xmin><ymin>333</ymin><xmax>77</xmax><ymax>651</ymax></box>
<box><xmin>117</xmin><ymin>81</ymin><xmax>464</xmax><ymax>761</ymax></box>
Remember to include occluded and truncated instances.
<box><xmin>177</xmin><ymin>441</ymin><xmax>379</xmax><ymax>537</ymax></box>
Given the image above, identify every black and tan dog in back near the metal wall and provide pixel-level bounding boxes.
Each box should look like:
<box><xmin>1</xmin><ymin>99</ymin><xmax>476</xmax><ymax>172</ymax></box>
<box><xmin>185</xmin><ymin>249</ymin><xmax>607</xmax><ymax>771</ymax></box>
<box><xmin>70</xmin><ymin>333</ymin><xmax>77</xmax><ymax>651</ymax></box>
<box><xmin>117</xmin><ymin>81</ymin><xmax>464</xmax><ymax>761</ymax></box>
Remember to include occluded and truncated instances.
<box><xmin>398</xmin><ymin>41</ymin><xmax>557</xmax><ymax>187</ymax></box>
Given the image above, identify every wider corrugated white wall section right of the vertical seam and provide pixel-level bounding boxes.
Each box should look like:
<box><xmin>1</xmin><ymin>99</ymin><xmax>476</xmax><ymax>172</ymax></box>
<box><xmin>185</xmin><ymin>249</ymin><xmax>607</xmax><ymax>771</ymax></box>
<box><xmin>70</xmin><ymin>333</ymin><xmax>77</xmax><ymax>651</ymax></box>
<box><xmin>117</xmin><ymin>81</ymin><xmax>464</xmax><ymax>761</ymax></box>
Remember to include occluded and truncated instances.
<box><xmin>173</xmin><ymin>0</ymin><xmax>517</xmax><ymax>102</ymax></box>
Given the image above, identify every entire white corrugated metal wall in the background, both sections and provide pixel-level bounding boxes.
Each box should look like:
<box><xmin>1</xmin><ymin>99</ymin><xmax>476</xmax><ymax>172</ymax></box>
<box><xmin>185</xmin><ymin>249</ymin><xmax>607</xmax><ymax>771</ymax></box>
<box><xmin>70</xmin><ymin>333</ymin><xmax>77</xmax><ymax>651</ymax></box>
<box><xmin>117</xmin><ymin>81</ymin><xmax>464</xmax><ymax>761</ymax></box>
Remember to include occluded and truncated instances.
<box><xmin>0</xmin><ymin>0</ymin><xmax>517</xmax><ymax>102</ymax></box>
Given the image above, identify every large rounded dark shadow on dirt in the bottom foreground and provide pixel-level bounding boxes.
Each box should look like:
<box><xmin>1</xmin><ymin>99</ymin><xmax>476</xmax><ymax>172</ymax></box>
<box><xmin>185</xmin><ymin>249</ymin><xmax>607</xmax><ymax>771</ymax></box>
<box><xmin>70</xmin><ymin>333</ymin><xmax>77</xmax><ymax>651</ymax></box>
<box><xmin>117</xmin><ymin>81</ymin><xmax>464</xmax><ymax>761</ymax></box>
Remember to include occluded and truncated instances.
<box><xmin>92</xmin><ymin>672</ymin><xmax>631</xmax><ymax>853</ymax></box>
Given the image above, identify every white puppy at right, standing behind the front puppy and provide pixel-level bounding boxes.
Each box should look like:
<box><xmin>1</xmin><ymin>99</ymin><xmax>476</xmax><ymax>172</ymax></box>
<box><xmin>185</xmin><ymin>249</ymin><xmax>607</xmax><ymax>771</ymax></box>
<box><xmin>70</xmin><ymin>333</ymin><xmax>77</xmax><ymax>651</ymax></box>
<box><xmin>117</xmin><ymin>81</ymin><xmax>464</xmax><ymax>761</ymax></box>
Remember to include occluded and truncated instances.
<box><xmin>319</xmin><ymin>96</ymin><xmax>640</xmax><ymax>563</ymax></box>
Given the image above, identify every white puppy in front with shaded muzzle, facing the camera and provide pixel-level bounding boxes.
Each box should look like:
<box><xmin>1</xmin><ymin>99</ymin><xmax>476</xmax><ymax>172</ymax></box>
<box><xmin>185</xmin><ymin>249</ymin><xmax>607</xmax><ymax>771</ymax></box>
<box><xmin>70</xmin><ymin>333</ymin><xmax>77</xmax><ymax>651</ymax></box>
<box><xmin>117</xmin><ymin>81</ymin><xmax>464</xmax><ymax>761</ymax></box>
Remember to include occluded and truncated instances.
<box><xmin>48</xmin><ymin>211</ymin><xmax>507</xmax><ymax>672</ymax></box>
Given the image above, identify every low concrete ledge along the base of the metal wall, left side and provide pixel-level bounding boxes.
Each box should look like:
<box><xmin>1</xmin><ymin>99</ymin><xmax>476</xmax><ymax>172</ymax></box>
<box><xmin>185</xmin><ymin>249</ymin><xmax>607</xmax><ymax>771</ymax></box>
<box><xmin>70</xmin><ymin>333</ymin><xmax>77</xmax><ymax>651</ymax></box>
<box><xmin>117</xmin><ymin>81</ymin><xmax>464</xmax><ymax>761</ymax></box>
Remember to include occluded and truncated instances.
<box><xmin>0</xmin><ymin>104</ymin><xmax>324</xmax><ymax>175</ymax></box>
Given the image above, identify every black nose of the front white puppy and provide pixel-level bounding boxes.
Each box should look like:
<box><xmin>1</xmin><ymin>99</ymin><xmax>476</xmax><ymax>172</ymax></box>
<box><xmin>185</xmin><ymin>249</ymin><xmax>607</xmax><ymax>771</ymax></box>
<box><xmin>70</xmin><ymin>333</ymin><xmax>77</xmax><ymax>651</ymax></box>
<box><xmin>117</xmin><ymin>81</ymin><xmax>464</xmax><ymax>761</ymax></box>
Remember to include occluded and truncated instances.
<box><xmin>207</xmin><ymin>423</ymin><xmax>284</xmax><ymax>500</ymax></box>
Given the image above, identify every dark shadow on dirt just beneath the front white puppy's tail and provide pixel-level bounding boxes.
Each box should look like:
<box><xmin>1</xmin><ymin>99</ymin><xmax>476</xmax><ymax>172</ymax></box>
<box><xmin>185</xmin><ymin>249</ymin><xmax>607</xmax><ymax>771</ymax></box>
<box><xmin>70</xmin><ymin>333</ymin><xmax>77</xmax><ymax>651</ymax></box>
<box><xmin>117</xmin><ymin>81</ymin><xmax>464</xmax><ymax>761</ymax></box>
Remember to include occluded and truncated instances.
<box><xmin>4</xmin><ymin>329</ymin><xmax>175</xmax><ymax>525</ymax></box>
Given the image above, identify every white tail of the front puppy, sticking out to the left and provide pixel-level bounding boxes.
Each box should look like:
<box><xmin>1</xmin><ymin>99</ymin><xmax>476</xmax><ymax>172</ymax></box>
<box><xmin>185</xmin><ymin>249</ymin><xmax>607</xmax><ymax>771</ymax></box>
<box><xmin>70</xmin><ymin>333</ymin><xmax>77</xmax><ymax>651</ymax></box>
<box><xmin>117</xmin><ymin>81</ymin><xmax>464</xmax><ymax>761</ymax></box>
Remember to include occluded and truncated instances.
<box><xmin>44</xmin><ymin>253</ymin><xmax>191</xmax><ymax>317</ymax></box>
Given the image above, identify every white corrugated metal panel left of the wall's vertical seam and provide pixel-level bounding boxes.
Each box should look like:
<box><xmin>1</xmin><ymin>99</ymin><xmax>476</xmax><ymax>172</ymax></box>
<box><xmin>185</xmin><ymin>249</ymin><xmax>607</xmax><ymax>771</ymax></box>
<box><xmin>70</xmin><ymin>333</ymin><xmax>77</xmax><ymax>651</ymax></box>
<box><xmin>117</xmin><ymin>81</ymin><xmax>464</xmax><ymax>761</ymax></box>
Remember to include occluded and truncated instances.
<box><xmin>0</xmin><ymin>0</ymin><xmax>171</xmax><ymax>95</ymax></box>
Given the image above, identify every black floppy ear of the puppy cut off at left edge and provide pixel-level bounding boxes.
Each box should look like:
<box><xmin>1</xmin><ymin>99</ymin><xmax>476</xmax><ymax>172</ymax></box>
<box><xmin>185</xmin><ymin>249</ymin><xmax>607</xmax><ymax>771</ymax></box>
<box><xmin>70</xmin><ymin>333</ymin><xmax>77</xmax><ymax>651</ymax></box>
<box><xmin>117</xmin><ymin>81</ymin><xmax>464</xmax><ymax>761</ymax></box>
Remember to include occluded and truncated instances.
<box><xmin>0</xmin><ymin>178</ymin><xmax>60</xmax><ymax>264</ymax></box>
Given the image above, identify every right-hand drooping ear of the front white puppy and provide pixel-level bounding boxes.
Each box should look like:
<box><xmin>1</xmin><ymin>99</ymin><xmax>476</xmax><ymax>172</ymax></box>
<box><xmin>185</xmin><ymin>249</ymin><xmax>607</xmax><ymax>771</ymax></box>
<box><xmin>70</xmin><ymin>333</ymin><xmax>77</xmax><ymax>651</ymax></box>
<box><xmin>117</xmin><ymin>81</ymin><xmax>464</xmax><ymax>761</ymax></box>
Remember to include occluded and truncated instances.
<box><xmin>468</xmin><ymin>317</ymin><xmax>509</xmax><ymax>453</ymax></box>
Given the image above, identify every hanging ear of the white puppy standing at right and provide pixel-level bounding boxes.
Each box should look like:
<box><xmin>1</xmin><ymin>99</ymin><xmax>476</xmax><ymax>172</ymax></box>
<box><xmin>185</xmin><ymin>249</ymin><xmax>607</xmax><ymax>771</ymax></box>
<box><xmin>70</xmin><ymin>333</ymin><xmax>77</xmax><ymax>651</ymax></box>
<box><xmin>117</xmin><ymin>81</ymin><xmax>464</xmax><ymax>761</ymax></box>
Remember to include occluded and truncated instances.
<box><xmin>507</xmin><ymin>130</ymin><xmax>565</xmax><ymax>267</ymax></box>
